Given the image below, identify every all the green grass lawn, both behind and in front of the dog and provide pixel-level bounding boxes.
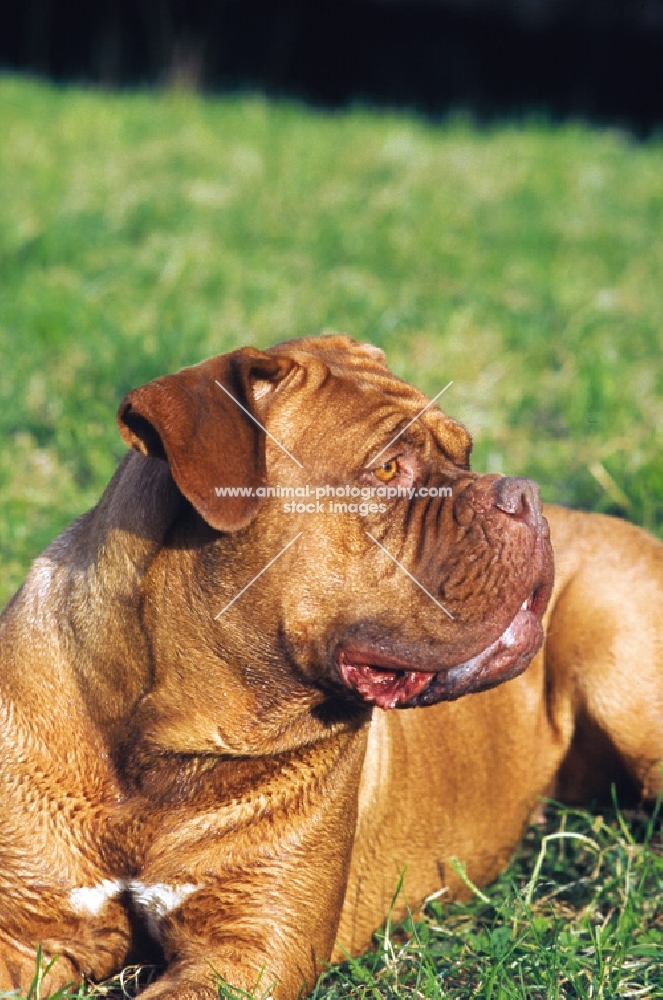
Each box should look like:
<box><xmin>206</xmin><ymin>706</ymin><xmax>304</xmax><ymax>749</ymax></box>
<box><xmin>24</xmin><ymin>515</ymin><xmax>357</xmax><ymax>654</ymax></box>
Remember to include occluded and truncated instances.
<box><xmin>0</xmin><ymin>77</ymin><xmax>663</xmax><ymax>1000</ymax></box>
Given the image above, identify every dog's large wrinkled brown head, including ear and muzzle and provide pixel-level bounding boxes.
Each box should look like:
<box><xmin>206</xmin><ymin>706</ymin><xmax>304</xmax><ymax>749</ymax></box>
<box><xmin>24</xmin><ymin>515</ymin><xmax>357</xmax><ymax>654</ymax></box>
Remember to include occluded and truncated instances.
<box><xmin>118</xmin><ymin>336</ymin><xmax>552</xmax><ymax>736</ymax></box>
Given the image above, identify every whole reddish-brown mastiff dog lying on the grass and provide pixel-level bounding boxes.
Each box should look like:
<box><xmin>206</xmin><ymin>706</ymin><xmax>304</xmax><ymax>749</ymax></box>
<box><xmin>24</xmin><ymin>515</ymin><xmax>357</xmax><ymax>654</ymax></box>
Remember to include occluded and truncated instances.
<box><xmin>0</xmin><ymin>336</ymin><xmax>663</xmax><ymax>1000</ymax></box>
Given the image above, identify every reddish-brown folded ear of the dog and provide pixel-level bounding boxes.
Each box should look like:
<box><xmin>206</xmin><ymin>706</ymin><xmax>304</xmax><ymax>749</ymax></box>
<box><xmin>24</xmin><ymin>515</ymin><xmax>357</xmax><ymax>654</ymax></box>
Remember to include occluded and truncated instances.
<box><xmin>117</xmin><ymin>347</ymin><xmax>294</xmax><ymax>531</ymax></box>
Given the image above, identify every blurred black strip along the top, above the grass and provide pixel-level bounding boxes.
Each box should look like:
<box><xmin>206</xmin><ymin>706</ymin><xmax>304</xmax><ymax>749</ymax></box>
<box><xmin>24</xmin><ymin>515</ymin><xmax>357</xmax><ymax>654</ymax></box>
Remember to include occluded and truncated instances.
<box><xmin>0</xmin><ymin>0</ymin><xmax>663</xmax><ymax>133</ymax></box>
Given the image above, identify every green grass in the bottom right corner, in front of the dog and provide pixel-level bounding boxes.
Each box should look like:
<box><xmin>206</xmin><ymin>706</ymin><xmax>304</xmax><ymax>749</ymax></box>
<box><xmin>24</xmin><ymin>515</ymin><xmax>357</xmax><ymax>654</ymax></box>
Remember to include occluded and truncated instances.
<box><xmin>314</xmin><ymin>806</ymin><xmax>663</xmax><ymax>1000</ymax></box>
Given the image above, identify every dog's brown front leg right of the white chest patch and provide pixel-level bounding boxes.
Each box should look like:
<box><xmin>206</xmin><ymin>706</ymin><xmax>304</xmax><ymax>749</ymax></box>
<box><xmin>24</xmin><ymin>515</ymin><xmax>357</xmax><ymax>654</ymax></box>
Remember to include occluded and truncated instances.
<box><xmin>132</xmin><ymin>730</ymin><xmax>365</xmax><ymax>1000</ymax></box>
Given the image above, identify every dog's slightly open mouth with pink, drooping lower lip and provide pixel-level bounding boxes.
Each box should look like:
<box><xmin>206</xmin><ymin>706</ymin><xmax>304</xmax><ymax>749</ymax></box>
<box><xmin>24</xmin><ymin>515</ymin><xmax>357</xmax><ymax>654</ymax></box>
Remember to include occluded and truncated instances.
<box><xmin>336</xmin><ymin>587</ymin><xmax>548</xmax><ymax>709</ymax></box>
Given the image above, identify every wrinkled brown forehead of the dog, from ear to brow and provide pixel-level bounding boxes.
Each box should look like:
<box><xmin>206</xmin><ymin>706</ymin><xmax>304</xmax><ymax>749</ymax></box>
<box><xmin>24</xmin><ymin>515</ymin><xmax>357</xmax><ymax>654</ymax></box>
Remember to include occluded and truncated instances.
<box><xmin>272</xmin><ymin>337</ymin><xmax>472</xmax><ymax>467</ymax></box>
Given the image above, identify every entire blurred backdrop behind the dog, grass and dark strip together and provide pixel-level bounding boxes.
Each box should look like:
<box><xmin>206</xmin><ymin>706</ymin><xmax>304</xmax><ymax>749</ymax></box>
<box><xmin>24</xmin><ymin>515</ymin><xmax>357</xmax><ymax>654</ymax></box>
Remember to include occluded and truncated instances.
<box><xmin>0</xmin><ymin>0</ymin><xmax>663</xmax><ymax>598</ymax></box>
